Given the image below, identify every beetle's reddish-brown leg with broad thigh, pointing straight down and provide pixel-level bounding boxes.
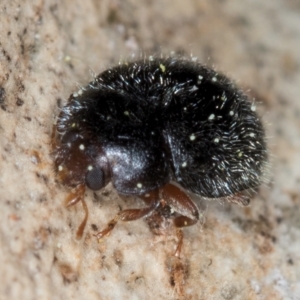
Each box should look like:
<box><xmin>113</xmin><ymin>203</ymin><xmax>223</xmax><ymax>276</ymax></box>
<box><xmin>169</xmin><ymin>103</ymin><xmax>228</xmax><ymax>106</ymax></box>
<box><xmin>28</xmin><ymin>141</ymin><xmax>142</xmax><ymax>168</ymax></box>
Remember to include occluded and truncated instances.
<box><xmin>160</xmin><ymin>183</ymin><xmax>199</xmax><ymax>257</ymax></box>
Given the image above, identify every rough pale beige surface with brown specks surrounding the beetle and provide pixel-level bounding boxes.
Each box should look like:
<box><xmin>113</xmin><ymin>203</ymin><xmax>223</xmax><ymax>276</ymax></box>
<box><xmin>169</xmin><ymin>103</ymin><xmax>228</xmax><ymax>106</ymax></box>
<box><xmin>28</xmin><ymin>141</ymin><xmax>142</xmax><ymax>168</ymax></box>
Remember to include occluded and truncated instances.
<box><xmin>0</xmin><ymin>0</ymin><xmax>300</xmax><ymax>300</ymax></box>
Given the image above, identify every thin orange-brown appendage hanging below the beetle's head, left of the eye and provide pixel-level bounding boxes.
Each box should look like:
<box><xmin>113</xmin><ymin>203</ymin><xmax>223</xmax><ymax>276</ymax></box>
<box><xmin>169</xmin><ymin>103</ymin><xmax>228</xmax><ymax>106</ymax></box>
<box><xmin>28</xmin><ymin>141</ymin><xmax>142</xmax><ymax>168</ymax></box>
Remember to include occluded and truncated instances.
<box><xmin>65</xmin><ymin>184</ymin><xmax>89</xmax><ymax>240</ymax></box>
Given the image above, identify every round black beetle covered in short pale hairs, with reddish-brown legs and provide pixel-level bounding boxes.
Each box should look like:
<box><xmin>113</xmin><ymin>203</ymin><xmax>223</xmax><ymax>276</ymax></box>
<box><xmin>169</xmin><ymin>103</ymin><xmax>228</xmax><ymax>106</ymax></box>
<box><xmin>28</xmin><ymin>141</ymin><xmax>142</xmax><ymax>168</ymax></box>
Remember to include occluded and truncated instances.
<box><xmin>54</xmin><ymin>57</ymin><xmax>267</xmax><ymax>252</ymax></box>
